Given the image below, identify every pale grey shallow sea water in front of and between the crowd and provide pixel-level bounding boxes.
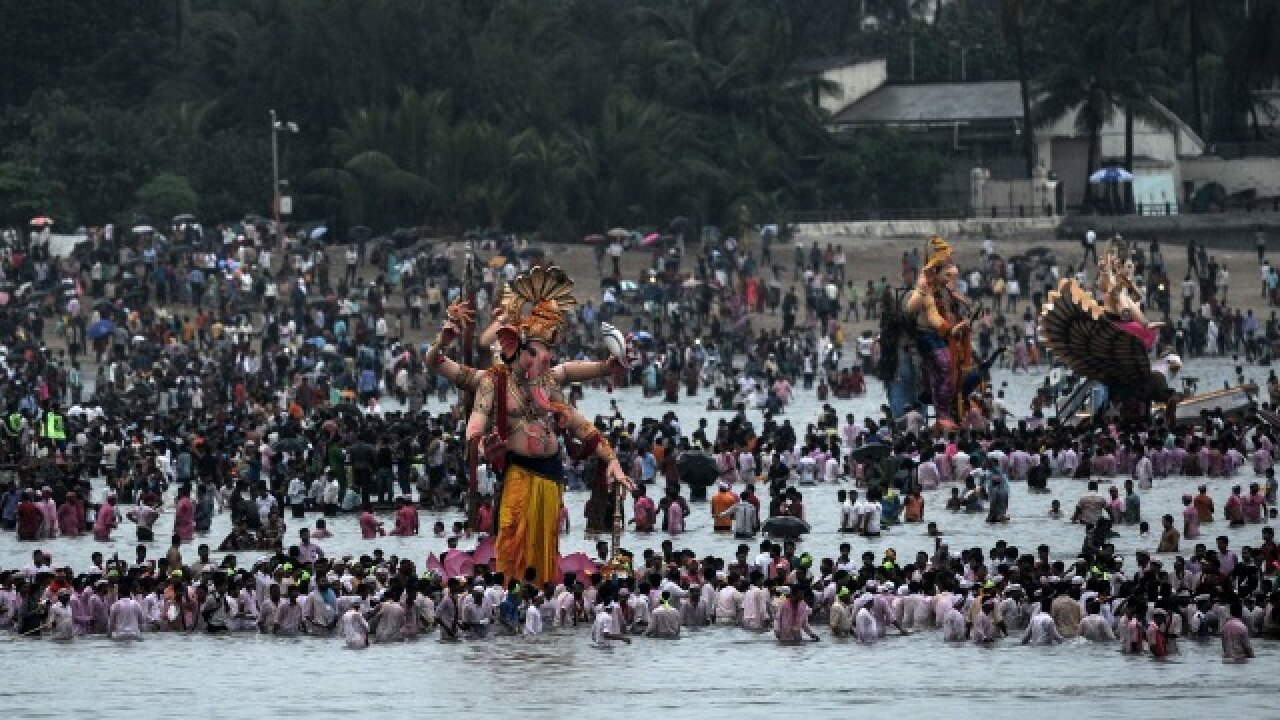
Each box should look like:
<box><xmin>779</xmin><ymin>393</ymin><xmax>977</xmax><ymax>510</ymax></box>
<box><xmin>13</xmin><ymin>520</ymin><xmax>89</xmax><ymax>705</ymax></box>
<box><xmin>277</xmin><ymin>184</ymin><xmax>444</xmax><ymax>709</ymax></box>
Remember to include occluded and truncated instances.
<box><xmin>0</xmin><ymin>360</ymin><xmax>1280</xmax><ymax>717</ymax></box>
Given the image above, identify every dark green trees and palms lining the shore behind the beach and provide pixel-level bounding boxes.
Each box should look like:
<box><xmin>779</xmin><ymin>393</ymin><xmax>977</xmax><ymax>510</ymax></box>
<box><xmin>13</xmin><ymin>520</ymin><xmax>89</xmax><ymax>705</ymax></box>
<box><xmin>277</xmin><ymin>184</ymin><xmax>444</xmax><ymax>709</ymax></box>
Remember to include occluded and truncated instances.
<box><xmin>0</xmin><ymin>0</ymin><xmax>1280</xmax><ymax>228</ymax></box>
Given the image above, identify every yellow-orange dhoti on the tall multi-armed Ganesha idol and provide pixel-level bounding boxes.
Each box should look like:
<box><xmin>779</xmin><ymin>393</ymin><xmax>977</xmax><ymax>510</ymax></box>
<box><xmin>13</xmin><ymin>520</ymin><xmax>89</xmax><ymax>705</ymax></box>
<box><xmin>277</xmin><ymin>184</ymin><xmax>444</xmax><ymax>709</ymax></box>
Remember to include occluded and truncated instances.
<box><xmin>494</xmin><ymin>454</ymin><xmax>563</xmax><ymax>585</ymax></box>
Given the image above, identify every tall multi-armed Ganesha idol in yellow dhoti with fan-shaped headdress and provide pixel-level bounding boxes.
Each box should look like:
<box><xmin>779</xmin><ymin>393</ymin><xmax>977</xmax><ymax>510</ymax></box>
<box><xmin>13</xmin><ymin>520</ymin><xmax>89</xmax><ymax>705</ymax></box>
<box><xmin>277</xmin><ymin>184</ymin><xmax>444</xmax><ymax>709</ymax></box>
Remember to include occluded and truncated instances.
<box><xmin>426</xmin><ymin>265</ymin><xmax>631</xmax><ymax>584</ymax></box>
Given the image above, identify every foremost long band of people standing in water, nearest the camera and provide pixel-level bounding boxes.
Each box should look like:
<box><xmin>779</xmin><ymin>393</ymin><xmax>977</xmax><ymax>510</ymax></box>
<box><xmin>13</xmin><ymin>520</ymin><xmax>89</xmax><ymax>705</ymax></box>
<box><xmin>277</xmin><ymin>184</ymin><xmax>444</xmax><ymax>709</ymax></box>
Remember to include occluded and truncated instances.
<box><xmin>0</xmin><ymin>476</ymin><xmax>1280</xmax><ymax>661</ymax></box>
